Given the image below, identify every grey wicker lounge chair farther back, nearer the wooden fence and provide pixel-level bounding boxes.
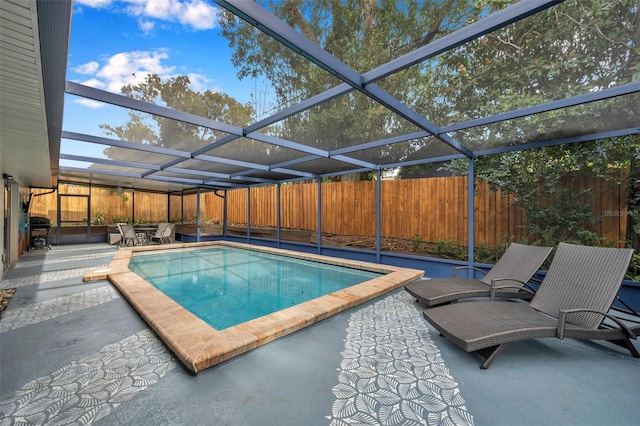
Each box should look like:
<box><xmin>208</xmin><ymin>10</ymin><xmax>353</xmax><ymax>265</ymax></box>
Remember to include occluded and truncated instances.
<box><xmin>404</xmin><ymin>243</ymin><xmax>552</xmax><ymax>307</ymax></box>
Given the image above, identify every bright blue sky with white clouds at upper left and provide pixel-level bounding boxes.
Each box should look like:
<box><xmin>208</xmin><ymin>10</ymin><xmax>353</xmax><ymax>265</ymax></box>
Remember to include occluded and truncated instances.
<box><xmin>61</xmin><ymin>0</ymin><xmax>265</xmax><ymax>163</ymax></box>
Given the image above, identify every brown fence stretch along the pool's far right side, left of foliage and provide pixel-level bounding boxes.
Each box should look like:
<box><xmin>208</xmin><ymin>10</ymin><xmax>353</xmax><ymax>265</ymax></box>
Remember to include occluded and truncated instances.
<box><xmin>224</xmin><ymin>177</ymin><xmax>525</xmax><ymax>245</ymax></box>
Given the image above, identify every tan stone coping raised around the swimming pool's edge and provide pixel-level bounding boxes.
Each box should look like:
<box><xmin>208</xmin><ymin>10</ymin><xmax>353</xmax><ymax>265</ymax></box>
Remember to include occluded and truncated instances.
<box><xmin>84</xmin><ymin>241</ymin><xmax>424</xmax><ymax>373</ymax></box>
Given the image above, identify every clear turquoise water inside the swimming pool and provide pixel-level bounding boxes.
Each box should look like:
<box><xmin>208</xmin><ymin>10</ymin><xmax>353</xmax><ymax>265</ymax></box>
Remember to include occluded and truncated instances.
<box><xmin>129</xmin><ymin>246</ymin><xmax>382</xmax><ymax>330</ymax></box>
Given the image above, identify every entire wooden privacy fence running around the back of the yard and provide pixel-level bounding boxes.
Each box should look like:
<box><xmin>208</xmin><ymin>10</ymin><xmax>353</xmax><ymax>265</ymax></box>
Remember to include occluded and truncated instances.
<box><xmin>31</xmin><ymin>176</ymin><xmax>627</xmax><ymax>246</ymax></box>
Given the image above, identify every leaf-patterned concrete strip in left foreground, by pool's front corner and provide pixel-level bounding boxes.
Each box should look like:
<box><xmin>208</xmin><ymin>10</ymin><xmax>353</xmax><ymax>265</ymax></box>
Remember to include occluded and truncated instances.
<box><xmin>0</xmin><ymin>330</ymin><xmax>176</xmax><ymax>426</ymax></box>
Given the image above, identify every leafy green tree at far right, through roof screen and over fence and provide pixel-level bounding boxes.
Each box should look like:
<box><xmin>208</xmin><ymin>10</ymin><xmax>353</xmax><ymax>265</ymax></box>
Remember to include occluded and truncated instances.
<box><xmin>441</xmin><ymin>0</ymin><xmax>640</xmax><ymax>245</ymax></box>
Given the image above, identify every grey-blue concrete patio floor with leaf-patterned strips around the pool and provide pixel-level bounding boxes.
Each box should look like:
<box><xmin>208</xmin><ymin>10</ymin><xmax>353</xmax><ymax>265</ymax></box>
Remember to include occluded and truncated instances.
<box><xmin>0</xmin><ymin>244</ymin><xmax>640</xmax><ymax>425</ymax></box>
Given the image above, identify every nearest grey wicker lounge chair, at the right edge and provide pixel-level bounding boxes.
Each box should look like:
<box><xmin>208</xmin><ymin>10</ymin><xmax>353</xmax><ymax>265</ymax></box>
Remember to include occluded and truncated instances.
<box><xmin>423</xmin><ymin>243</ymin><xmax>640</xmax><ymax>369</ymax></box>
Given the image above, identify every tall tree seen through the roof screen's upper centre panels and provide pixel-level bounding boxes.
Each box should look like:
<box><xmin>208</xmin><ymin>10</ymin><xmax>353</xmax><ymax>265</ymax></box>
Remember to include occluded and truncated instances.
<box><xmin>220</xmin><ymin>0</ymin><xmax>506</xmax><ymax>177</ymax></box>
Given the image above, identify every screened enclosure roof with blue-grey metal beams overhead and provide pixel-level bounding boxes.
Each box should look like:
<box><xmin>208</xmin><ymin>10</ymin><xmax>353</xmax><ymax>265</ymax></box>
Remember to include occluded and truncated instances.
<box><xmin>2</xmin><ymin>0</ymin><xmax>640</xmax><ymax>192</ymax></box>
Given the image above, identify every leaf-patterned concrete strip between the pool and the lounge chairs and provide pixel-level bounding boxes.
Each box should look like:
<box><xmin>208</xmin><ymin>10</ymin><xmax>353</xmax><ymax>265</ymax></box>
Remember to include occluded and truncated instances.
<box><xmin>327</xmin><ymin>292</ymin><xmax>473</xmax><ymax>426</ymax></box>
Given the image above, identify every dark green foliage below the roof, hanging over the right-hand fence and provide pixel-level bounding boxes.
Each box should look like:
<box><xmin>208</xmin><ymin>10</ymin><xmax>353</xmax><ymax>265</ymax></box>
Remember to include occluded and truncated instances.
<box><xmin>445</xmin><ymin>136</ymin><xmax>640</xmax><ymax>250</ymax></box>
